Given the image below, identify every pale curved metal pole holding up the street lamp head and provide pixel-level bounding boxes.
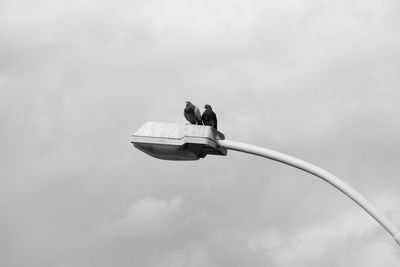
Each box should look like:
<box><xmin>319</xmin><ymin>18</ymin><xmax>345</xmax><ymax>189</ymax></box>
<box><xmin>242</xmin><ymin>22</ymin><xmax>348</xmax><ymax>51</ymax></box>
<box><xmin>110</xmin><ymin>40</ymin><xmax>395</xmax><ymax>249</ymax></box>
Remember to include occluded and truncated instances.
<box><xmin>218</xmin><ymin>140</ymin><xmax>400</xmax><ymax>245</ymax></box>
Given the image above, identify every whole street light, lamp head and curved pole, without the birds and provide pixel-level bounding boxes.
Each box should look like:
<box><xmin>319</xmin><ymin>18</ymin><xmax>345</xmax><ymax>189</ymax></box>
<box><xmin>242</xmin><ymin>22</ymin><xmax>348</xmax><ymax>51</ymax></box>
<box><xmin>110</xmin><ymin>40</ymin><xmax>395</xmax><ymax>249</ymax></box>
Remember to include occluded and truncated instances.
<box><xmin>131</xmin><ymin>122</ymin><xmax>400</xmax><ymax>245</ymax></box>
